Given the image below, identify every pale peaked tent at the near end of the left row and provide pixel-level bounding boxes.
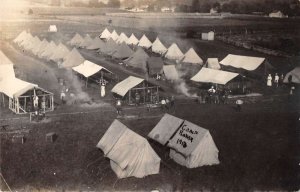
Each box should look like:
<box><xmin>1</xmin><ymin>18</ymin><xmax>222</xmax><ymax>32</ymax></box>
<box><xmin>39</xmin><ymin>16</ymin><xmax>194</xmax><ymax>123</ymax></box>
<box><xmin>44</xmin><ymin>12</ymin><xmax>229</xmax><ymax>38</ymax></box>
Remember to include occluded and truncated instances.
<box><xmin>59</xmin><ymin>48</ymin><xmax>85</xmax><ymax>68</ymax></box>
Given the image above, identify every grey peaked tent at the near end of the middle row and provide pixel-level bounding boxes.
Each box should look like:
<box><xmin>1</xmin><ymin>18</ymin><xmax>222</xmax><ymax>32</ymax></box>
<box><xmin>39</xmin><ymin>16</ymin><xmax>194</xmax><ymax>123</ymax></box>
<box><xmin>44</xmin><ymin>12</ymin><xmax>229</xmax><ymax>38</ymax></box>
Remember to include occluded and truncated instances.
<box><xmin>124</xmin><ymin>47</ymin><xmax>149</xmax><ymax>72</ymax></box>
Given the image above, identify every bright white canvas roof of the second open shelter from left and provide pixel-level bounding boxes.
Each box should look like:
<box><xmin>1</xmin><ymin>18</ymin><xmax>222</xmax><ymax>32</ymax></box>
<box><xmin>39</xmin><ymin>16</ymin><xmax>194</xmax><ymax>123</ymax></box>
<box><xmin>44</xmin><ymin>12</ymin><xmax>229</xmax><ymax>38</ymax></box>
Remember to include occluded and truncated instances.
<box><xmin>72</xmin><ymin>60</ymin><xmax>111</xmax><ymax>78</ymax></box>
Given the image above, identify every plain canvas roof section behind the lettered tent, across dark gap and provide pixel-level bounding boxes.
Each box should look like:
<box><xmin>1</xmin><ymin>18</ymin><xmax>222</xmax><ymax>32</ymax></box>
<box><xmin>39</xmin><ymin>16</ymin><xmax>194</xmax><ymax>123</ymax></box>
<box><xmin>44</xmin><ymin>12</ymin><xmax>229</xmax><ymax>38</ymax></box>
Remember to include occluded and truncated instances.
<box><xmin>148</xmin><ymin>113</ymin><xmax>184</xmax><ymax>145</ymax></box>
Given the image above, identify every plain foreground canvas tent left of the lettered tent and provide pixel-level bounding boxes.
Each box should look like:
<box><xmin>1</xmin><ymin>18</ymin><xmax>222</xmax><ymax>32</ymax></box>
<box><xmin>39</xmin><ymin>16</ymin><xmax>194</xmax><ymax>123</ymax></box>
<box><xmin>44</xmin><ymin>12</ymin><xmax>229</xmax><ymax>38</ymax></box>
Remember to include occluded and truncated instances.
<box><xmin>97</xmin><ymin>120</ymin><xmax>160</xmax><ymax>178</ymax></box>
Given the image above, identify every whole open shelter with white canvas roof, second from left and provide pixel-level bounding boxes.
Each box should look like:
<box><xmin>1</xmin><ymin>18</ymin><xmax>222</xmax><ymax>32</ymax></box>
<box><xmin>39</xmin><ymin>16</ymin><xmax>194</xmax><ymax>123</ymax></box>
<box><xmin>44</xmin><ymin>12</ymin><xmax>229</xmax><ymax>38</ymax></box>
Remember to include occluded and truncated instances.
<box><xmin>72</xmin><ymin>60</ymin><xmax>112</xmax><ymax>86</ymax></box>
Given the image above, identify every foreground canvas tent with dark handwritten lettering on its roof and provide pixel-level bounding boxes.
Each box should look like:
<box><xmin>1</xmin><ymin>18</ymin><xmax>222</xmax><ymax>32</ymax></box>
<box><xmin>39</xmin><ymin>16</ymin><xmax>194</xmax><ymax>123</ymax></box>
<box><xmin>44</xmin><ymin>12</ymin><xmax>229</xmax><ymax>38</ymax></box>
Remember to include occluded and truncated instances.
<box><xmin>167</xmin><ymin>121</ymin><xmax>220</xmax><ymax>168</ymax></box>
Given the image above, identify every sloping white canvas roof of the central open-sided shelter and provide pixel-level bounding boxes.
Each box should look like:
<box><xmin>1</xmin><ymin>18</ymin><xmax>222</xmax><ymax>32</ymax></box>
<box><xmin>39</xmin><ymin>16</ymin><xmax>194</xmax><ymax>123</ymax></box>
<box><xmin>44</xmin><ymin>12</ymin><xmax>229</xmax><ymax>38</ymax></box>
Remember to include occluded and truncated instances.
<box><xmin>111</xmin><ymin>76</ymin><xmax>144</xmax><ymax>97</ymax></box>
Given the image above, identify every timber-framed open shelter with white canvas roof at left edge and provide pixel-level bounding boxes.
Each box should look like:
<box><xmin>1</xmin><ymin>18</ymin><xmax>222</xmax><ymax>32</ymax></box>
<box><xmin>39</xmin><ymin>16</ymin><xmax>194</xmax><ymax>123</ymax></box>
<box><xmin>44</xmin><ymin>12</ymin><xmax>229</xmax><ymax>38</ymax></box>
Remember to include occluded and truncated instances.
<box><xmin>0</xmin><ymin>78</ymin><xmax>54</xmax><ymax>114</ymax></box>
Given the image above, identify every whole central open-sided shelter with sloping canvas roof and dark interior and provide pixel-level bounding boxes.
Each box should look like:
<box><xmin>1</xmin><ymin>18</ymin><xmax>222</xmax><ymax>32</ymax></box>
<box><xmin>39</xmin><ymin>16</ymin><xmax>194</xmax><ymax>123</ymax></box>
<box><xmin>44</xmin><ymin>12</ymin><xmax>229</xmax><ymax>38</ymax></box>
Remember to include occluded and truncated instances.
<box><xmin>111</xmin><ymin>76</ymin><xmax>159</xmax><ymax>105</ymax></box>
